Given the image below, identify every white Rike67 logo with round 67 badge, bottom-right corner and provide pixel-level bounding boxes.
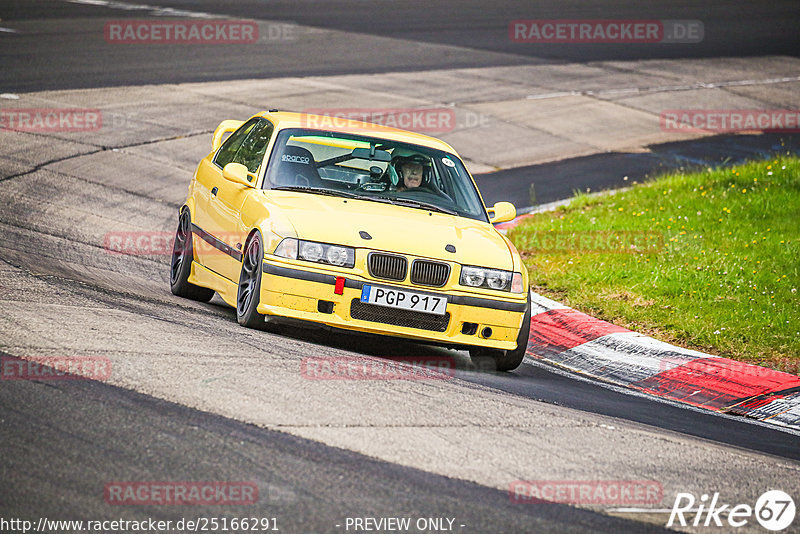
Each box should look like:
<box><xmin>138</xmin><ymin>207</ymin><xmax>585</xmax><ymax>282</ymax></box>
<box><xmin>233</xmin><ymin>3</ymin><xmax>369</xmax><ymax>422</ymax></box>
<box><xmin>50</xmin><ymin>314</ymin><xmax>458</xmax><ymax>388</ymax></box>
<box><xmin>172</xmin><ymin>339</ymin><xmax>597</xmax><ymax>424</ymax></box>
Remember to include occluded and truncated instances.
<box><xmin>666</xmin><ymin>490</ymin><xmax>797</xmax><ymax>532</ymax></box>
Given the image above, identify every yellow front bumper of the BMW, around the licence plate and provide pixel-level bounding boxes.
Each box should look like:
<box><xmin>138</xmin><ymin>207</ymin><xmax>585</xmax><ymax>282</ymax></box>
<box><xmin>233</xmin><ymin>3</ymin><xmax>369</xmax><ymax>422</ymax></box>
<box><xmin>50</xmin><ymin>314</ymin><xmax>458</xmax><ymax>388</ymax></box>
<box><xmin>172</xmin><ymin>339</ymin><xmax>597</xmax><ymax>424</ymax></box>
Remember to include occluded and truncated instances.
<box><xmin>257</xmin><ymin>258</ymin><xmax>527</xmax><ymax>350</ymax></box>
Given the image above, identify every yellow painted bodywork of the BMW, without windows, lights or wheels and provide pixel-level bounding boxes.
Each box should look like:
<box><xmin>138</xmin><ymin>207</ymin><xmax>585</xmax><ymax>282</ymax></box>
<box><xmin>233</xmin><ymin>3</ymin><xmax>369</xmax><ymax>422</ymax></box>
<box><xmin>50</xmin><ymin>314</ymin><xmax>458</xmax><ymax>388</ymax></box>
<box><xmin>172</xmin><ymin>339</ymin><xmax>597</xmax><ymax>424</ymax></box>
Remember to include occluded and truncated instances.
<box><xmin>182</xmin><ymin>112</ymin><xmax>529</xmax><ymax>350</ymax></box>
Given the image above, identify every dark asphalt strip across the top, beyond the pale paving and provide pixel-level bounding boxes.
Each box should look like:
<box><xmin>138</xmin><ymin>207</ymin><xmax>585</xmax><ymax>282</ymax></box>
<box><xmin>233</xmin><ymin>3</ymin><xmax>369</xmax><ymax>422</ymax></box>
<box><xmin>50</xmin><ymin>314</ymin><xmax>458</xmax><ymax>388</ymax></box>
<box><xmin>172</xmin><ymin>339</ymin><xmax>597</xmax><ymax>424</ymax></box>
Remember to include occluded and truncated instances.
<box><xmin>0</xmin><ymin>0</ymin><xmax>800</xmax><ymax>91</ymax></box>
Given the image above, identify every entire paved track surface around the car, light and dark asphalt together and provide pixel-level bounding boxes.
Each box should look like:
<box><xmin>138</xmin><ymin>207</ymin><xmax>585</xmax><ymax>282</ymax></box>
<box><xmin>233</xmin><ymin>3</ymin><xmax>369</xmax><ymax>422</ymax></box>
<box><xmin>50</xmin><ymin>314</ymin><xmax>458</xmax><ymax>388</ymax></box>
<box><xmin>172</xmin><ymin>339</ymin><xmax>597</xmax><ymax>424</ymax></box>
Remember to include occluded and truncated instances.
<box><xmin>0</xmin><ymin>0</ymin><xmax>800</xmax><ymax>533</ymax></box>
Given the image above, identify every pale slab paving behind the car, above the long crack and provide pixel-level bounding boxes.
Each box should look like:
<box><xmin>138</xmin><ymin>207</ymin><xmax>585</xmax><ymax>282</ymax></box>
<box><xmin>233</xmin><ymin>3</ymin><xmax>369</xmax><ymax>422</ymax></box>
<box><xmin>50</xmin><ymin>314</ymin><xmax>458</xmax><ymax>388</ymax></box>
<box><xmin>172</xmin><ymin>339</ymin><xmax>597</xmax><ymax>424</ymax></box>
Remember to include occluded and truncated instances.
<box><xmin>0</xmin><ymin>56</ymin><xmax>800</xmax><ymax>179</ymax></box>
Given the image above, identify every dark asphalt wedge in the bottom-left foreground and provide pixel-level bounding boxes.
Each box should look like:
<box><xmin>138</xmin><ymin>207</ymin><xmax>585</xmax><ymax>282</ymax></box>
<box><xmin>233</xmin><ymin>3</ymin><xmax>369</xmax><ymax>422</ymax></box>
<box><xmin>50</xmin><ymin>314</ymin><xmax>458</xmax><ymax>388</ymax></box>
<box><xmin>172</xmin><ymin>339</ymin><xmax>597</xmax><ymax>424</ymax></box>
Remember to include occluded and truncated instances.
<box><xmin>1</xmin><ymin>356</ymin><xmax>664</xmax><ymax>532</ymax></box>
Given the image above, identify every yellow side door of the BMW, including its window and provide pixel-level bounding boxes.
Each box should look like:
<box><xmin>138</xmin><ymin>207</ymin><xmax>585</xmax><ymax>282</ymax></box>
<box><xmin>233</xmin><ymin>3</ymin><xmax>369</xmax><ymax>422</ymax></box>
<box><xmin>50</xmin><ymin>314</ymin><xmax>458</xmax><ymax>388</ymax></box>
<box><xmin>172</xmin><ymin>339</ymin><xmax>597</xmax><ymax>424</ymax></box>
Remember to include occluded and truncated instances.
<box><xmin>195</xmin><ymin>118</ymin><xmax>274</xmax><ymax>282</ymax></box>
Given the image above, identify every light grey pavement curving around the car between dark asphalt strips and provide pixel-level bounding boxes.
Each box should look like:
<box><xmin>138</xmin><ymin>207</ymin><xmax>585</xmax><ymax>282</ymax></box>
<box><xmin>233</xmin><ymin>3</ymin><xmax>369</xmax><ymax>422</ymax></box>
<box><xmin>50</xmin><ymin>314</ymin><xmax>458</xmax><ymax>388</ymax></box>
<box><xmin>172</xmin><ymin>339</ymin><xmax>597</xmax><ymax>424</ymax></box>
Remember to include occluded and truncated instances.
<box><xmin>0</xmin><ymin>53</ymin><xmax>800</xmax><ymax>525</ymax></box>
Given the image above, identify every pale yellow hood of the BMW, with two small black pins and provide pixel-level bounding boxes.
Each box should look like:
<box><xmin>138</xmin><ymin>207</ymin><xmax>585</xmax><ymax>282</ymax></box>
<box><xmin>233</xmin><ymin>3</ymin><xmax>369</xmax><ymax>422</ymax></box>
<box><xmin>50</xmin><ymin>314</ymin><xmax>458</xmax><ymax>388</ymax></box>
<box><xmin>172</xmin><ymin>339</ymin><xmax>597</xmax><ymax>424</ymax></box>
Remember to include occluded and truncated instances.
<box><xmin>266</xmin><ymin>191</ymin><xmax>514</xmax><ymax>270</ymax></box>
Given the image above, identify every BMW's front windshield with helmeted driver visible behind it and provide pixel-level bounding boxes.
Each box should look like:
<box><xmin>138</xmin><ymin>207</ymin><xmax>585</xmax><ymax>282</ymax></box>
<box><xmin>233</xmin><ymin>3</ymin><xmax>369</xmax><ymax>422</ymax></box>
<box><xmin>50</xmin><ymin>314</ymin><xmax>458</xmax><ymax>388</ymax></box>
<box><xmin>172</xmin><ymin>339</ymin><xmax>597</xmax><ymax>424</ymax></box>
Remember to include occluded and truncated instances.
<box><xmin>264</xmin><ymin>129</ymin><xmax>487</xmax><ymax>221</ymax></box>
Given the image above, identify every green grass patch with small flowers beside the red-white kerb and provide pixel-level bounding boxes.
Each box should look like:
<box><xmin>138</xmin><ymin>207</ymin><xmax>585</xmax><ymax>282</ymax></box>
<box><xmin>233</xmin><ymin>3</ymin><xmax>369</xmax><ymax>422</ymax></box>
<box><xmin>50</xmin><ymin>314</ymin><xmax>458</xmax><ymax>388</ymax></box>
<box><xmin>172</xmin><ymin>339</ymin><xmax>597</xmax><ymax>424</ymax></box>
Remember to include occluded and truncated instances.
<box><xmin>509</xmin><ymin>156</ymin><xmax>800</xmax><ymax>374</ymax></box>
